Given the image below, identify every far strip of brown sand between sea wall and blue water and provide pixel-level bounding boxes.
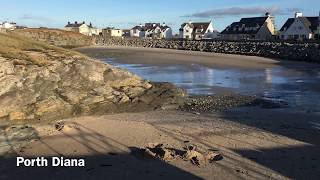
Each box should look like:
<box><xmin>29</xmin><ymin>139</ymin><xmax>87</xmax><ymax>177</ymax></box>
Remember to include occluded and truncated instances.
<box><xmin>74</xmin><ymin>46</ymin><xmax>320</xmax><ymax>69</ymax></box>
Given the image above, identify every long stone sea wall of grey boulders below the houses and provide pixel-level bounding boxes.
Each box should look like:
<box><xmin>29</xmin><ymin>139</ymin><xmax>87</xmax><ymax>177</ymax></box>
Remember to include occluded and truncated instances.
<box><xmin>96</xmin><ymin>38</ymin><xmax>320</xmax><ymax>63</ymax></box>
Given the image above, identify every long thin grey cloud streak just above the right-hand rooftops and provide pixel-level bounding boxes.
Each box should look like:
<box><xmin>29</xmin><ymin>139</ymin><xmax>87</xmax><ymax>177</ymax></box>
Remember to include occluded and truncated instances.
<box><xmin>184</xmin><ymin>6</ymin><xmax>300</xmax><ymax>18</ymax></box>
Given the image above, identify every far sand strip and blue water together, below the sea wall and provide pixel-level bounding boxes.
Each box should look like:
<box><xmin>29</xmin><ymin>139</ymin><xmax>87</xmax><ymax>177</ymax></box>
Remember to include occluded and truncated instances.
<box><xmin>77</xmin><ymin>47</ymin><xmax>320</xmax><ymax>112</ymax></box>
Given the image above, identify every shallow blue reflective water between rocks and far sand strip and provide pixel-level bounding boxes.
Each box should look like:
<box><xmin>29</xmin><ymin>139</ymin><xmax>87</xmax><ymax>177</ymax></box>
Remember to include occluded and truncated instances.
<box><xmin>103</xmin><ymin>58</ymin><xmax>320</xmax><ymax>111</ymax></box>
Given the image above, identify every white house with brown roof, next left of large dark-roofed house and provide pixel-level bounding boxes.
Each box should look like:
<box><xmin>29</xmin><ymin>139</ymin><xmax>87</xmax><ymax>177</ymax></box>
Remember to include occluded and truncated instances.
<box><xmin>179</xmin><ymin>22</ymin><xmax>219</xmax><ymax>40</ymax></box>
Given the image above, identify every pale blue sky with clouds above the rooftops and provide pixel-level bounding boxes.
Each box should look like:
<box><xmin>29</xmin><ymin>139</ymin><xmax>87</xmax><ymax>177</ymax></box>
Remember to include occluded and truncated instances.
<box><xmin>0</xmin><ymin>0</ymin><xmax>320</xmax><ymax>33</ymax></box>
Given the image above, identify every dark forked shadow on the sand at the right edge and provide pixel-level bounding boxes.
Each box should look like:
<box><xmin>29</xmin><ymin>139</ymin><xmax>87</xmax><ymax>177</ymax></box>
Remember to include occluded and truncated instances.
<box><xmin>222</xmin><ymin>109</ymin><xmax>320</xmax><ymax>179</ymax></box>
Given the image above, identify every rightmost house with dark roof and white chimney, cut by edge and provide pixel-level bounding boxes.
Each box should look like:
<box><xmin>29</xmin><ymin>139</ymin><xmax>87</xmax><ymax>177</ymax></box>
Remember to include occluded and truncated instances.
<box><xmin>280</xmin><ymin>12</ymin><xmax>320</xmax><ymax>40</ymax></box>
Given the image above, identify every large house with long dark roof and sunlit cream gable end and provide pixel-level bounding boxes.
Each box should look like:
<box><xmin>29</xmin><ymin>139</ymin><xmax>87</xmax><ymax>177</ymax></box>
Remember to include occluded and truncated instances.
<box><xmin>221</xmin><ymin>13</ymin><xmax>276</xmax><ymax>40</ymax></box>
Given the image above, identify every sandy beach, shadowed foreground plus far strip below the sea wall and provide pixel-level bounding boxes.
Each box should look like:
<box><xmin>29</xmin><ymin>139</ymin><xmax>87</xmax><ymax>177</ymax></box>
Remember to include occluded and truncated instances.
<box><xmin>0</xmin><ymin>47</ymin><xmax>320</xmax><ymax>180</ymax></box>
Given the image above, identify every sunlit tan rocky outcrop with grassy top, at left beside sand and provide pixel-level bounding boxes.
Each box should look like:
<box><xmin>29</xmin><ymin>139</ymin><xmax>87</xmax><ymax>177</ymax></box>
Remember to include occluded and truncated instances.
<box><xmin>0</xmin><ymin>33</ymin><xmax>185</xmax><ymax>120</ymax></box>
